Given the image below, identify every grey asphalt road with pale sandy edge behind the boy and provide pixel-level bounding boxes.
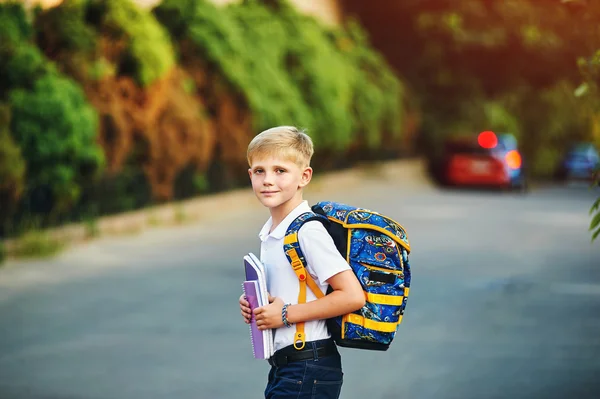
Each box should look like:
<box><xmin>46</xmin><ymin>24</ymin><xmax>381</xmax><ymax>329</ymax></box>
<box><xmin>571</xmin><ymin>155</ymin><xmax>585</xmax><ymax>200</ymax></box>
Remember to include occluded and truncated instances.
<box><xmin>0</xmin><ymin>181</ymin><xmax>600</xmax><ymax>399</ymax></box>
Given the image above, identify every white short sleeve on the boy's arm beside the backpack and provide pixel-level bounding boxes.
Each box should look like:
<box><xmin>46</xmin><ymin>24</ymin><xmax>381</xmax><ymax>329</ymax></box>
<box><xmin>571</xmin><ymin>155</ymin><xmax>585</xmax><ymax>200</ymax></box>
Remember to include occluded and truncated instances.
<box><xmin>298</xmin><ymin>220</ymin><xmax>350</xmax><ymax>285</ymax></box>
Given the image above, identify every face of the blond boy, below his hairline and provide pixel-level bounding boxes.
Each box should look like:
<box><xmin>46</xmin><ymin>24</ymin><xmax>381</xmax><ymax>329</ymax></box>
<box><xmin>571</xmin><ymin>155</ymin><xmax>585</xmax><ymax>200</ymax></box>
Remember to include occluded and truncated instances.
<box><xmin>248</xmin><ymin>156</ymin><xmax>312</xmax><ymax>216</ymax></box>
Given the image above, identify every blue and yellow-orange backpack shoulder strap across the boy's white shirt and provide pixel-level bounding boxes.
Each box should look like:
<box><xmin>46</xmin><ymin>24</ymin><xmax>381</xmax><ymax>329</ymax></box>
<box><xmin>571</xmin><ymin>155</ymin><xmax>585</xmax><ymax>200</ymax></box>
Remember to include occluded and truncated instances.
<box><xmin>283</xmin><ymin>212</ymin><xmax>329</xmax><ymax>350</ymax></box>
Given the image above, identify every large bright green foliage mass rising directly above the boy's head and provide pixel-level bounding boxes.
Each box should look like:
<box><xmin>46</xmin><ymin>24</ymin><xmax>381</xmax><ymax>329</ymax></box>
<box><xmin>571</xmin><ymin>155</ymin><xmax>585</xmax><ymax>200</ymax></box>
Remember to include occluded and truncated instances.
<box><xmin>154</xmin><ymin>0</ymin><xmax>402</xmax><ymax>150</ymax></box>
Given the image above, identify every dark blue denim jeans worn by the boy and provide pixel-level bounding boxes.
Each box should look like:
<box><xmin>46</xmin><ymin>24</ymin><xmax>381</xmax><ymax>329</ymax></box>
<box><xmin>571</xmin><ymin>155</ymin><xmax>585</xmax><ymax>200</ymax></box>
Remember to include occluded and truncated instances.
<box><xmin>265</xmin><ymin>342</ymin><xmax>344</xmax><ymax>399</ymax></box>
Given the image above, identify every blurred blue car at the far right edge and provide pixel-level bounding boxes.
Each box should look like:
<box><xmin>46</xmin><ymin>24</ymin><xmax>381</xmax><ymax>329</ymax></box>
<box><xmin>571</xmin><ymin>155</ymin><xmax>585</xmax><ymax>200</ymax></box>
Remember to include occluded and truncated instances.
<box><xmin>556</xmin><ymin>143</ymin><xmax>600</xmax><ymax>181</ymax></box>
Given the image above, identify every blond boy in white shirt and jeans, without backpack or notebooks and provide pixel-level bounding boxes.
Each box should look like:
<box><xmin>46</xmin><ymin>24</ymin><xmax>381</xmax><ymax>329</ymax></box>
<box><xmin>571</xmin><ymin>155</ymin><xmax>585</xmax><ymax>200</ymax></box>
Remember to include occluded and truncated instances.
<box><xmin>239</xmin><ymin>126</ymin><xmax>365</xmax><ymax>399</ymax></box>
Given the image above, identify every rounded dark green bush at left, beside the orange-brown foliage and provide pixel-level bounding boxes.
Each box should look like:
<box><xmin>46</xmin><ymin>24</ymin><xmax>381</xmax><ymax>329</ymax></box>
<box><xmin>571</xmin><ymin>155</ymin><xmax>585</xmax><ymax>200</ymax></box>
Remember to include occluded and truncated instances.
<box><xmin>9</xmin><ymin>74</ymin><xmax>103</xmax><ymax>210</ymax></box>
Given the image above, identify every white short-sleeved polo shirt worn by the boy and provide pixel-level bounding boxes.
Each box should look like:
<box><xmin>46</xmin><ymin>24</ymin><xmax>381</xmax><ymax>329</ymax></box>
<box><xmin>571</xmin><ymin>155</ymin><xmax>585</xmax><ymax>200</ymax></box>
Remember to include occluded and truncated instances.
<box><xmin>259</xmin><ymin>201</ymin><xmax>350</xmax><ymax>350</ymax></box>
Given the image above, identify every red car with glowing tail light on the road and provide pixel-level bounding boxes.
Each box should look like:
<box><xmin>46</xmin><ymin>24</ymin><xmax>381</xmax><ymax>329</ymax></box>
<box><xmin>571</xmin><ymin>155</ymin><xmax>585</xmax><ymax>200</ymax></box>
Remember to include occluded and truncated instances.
<box><xmin>439</xmin><ymin>131</ymin><xmax>527</xmax><ymax>191</ymax></box>
